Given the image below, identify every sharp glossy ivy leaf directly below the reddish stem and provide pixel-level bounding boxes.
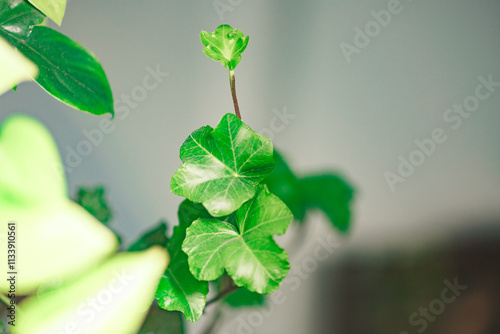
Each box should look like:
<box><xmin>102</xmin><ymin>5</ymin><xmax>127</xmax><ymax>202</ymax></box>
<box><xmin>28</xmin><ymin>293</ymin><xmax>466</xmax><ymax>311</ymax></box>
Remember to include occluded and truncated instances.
<box><xmin>170</xmin><ymin>114</ymin><xmax>274</xmax><ymax>217</ymax></box>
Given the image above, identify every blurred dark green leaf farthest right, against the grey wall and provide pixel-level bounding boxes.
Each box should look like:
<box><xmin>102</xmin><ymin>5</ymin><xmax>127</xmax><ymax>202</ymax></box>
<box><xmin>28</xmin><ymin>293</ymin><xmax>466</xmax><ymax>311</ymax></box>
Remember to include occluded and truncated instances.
<box><xmin>299</xmin><ymin>174</ymin><xmax>353</xmax><ymax>232</ymax></box>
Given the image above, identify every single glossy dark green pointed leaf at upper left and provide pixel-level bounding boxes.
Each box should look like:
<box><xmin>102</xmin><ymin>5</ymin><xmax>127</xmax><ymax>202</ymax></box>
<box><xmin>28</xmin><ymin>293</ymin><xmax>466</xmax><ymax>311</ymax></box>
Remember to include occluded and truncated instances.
<box><xmin>0</xmin><ymin>25</ymin><xmax>114</xmax><ymax>115</ymax></box>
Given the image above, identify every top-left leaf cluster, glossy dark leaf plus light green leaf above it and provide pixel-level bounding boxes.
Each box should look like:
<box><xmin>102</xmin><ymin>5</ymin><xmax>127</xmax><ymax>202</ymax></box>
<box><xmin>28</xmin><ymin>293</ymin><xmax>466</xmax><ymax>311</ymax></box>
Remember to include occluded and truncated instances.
<box><xmin>0</xmin><ymin>0</ymin><xmax>114</xmax><ymax>115</ymax></box>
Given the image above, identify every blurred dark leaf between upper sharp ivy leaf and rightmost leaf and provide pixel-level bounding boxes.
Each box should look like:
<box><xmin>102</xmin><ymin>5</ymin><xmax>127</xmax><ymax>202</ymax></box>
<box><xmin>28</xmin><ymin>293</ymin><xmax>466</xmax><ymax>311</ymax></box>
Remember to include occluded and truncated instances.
<box><xmin>264</xmin><ymin>150</ymin><xmax>306</xmax><ymax>220</ymax></box>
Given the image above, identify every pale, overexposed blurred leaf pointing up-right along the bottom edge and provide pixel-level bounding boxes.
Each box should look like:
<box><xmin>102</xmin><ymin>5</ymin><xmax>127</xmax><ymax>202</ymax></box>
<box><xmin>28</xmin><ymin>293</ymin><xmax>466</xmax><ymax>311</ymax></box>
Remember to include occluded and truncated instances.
<box><xmin>12</xmin><ymin>246</ymin><xmax>168</xmax><ymax>334</ymax></box>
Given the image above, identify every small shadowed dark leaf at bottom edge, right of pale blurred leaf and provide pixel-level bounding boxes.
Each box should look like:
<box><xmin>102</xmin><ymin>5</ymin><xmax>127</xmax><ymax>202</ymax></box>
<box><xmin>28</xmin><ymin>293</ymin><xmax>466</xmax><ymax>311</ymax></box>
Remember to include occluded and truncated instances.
<box><xmin>139</xmin><ymin>302</ymin><xmax>184</xmax><ymax>334</ymax></box>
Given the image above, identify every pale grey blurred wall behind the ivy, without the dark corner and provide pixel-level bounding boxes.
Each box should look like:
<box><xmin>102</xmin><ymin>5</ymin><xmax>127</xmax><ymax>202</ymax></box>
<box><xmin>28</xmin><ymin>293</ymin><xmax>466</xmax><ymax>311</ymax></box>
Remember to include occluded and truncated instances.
<box><xmin>0</xmin><ymin>0</ymin><xmax>500</xmax><ymax>333</ymax></box>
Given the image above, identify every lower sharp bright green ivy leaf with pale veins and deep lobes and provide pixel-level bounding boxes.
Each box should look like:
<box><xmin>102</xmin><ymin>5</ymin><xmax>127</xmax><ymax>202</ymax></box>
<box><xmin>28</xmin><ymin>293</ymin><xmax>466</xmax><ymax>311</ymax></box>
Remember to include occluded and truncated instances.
<box><xmin>182</xmin><ymin>186</ymin><xmax>292</xmax><ymax>293</ymax></box>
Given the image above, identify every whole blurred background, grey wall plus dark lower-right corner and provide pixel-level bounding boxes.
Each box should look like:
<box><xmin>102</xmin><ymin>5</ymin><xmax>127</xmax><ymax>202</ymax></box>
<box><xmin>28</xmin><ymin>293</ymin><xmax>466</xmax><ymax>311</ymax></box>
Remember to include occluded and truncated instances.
<box><xmin>0</xmin><ymin>0</ymin><xmax>500</xmax><ymax>334</ymax></box>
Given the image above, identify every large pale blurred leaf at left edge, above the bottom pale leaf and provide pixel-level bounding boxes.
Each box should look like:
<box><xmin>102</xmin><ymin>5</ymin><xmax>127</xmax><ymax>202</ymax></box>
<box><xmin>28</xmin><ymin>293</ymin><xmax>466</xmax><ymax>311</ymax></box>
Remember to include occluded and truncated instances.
<box><xmin>0</xmin><ymin>116</ymin><xmax>117</xmax><ymax>294</ymax></box>
